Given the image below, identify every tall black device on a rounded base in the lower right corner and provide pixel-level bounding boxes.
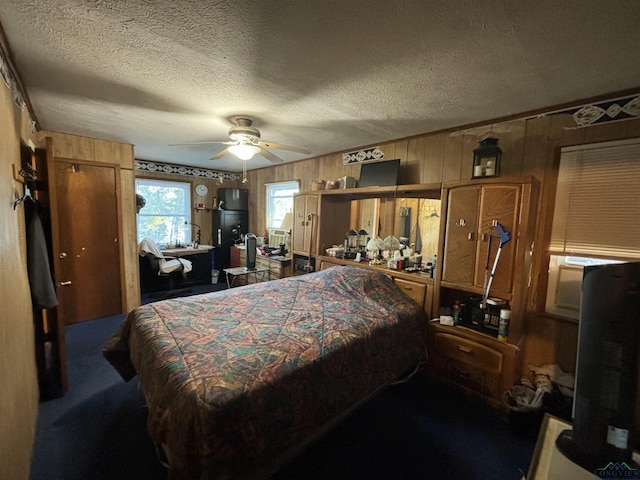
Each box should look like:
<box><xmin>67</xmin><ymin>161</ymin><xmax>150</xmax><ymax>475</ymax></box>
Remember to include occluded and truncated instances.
<box><xmin>556</xmin><ymin>262</ymin><xmax>640</xmax><ymax>472</ymax></box>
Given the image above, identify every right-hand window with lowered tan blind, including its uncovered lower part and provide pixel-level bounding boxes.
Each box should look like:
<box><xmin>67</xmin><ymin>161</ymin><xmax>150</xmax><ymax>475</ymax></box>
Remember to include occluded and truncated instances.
<box><xmin>545</xmin><ymin>140</ymin><xmax>640</xmax><ymax>319</ymax></box>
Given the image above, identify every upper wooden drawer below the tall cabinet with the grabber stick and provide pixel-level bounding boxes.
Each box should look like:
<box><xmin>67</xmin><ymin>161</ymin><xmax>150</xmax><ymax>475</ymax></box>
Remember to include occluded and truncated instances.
<box><xmin>434</xmin><ymin>332</ymin><xmax>503</xmax><ymax>373</ymax></box>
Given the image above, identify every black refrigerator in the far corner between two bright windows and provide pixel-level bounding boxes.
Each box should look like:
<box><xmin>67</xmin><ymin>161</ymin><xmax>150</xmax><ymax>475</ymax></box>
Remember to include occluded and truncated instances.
<box><xmin>212</xmin><ymin>210</ymin><xmax>249</xmax><ymax>279</ymax></box>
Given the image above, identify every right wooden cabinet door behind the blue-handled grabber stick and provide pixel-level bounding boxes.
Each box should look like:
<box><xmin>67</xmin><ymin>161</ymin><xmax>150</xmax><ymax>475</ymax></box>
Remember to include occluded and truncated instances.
<box><xmin>475</xmin><ymin>185</ymin><xmax>520</xmax><ymax>297</ymax></box>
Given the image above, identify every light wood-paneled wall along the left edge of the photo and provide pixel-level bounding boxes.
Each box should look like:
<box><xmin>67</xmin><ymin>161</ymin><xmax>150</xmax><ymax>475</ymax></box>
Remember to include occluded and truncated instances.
<box><xmin>0</xmin><ymin>83</ymin><xmax>39</xmax><ymax>479</ymax></box>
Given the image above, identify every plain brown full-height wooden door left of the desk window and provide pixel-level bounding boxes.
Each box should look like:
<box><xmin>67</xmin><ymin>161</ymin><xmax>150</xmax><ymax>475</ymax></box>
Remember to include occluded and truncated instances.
<box><xmin>49</xmin><ymin>158</ymin><xmax>123</xmax><ymax>325</ymax></box>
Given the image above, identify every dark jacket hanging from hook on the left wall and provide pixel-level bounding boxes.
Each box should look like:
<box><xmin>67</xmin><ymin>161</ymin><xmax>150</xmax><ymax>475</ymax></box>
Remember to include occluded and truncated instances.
<box><xmin>24</xmin><ymin>201</ymin><xmax>58</xmax><ymax>308</ymax></box>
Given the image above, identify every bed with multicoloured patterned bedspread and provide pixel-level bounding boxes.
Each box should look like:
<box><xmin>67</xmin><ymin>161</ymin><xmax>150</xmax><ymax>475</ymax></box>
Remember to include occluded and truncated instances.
<box><xmin>104</xmin><ymin>267</ymin><xmax>427</xmax><ymax>479</ymax></box>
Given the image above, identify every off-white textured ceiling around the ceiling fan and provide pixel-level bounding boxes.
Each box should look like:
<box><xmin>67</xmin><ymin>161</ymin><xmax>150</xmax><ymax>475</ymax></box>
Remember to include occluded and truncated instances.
<box><xmin>0</xmin><ymin>0</ymin><xmax>640</xmax><ymax>171</ymax></box>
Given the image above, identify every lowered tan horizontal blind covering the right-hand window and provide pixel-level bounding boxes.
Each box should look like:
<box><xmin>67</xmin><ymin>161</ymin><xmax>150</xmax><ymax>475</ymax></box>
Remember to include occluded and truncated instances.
<box><xmin>550</xmin><ymin>139</ymin><xmax>640</xmax><ymax>259</ymax></box>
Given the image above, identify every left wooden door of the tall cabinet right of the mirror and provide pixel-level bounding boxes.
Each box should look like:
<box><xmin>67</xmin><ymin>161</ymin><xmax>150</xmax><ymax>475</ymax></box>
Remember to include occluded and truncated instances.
<box><xmin>442</xmin><ymin>186</ymin><xmax>480</xmax><ymax>286</ymax></box>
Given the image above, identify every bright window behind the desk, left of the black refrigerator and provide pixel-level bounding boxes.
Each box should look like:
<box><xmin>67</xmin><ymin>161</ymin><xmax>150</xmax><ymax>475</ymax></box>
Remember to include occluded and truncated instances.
<box><xmin>136</xmin><ymin>179</ymin><xmax>191</xmax><ymax>247</ymax></box>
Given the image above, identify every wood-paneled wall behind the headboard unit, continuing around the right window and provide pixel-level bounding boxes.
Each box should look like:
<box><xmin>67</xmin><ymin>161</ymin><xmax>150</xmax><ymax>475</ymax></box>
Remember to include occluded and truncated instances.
<box><xmin>246</xmin><ymin>115</ymin><xmax>640</xmax><ymax>371</ymax></box>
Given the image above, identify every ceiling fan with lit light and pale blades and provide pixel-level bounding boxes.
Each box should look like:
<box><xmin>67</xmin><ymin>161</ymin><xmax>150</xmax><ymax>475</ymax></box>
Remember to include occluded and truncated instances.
<box><xmin>170</xmin><ymin>115</ymin><xmax>311</xmax><ymax>163</ymax></box>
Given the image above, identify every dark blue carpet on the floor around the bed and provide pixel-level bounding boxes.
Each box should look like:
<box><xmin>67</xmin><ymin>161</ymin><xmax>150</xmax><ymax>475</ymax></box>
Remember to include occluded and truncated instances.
<box><xmin>30</xmin><ymin>284</ymin><xmax>535</xmax><ymax>480</ymax></box>
